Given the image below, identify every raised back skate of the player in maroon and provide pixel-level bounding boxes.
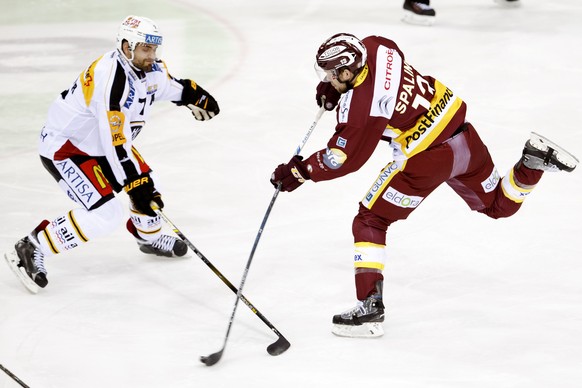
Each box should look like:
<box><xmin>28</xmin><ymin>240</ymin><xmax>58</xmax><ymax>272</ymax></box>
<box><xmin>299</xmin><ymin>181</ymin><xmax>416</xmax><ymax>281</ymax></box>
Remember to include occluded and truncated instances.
<box><xmin>521</xmin><ymin>132</ymin><xmax>578</xmax><ymax>172</ymax></box>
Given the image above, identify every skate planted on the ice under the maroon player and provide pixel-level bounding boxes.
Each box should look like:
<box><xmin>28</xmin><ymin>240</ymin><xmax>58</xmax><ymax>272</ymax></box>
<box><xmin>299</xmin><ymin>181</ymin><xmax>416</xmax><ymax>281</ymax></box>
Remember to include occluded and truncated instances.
<box><xmin>331</xmin><ymin>296</ymin><xmax>384</xmax><ymax>338</ymax></box>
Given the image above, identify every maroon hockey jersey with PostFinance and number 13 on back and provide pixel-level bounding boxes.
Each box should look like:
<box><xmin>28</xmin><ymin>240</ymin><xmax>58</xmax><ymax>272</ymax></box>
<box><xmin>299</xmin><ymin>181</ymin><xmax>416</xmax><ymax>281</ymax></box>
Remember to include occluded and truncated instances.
<box><xmin>306</xmin><ymin>36</ymin><xmax>466</xmax><ymax>182</ymax></box>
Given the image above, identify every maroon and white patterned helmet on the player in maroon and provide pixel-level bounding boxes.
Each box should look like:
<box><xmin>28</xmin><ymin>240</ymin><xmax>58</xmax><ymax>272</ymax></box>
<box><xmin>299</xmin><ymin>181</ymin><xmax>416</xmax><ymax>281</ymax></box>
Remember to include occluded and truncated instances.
<box><xmin>315</xmin><ymin>33</ymin><xmax>368</xmax><ymax>81</ymax></box>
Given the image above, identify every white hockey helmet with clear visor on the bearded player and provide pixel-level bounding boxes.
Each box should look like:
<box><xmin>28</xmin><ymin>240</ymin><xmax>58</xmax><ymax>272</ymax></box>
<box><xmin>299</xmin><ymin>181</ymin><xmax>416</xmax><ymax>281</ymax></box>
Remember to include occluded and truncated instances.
<box><xmin>117</xmin><ymin>15</ymin><xmax>163</xmax><ymax>56</ymax></box>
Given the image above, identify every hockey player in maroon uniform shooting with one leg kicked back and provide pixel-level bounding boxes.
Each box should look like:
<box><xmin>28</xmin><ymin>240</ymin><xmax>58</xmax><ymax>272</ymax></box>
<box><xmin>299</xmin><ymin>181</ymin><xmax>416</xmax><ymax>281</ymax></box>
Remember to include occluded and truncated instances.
<box><xmin>271</xmin><ymin>34</ymin><xmax>578</xmax><ymax>337</ymax></box>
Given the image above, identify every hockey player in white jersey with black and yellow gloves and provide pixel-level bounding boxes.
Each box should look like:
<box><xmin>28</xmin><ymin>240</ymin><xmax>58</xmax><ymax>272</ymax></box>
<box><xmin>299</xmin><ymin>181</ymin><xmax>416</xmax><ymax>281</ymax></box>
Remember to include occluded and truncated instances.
<box><xmin>5</xmin><ymin>16</ymin><xmax>220</xmax><ymax>292</ymax></box>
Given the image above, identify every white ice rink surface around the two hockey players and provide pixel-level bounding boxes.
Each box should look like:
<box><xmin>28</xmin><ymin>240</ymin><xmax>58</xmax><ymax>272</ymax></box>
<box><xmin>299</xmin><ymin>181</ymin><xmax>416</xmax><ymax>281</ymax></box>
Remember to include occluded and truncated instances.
<box><xmin>0</xmin><ymin>0</ymin><xmax>582</xmax><ymax>388</ymax></box>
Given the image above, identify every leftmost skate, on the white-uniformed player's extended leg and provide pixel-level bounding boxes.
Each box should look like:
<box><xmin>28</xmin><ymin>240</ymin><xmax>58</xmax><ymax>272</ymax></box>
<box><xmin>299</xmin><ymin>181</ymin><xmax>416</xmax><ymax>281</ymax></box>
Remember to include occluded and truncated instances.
<box><xmin>4</xmin><ymin>232</ymin><xmax>48</xmax><ymax>294</ymax></box>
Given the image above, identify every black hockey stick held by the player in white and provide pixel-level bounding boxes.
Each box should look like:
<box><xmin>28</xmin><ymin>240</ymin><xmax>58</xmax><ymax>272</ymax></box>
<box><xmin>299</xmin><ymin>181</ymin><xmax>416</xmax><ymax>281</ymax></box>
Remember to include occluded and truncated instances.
<box><xmin>152</xmin><ymin>209</ymin><xmax>290</xmax><ymax>356</ymax></box>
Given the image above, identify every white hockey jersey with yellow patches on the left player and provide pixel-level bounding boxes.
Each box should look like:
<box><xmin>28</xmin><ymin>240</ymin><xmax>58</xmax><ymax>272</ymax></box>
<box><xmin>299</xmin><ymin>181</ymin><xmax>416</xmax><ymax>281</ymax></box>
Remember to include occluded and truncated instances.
<box><xmin>39</xmin><ymin>50</ymin><xmax>183</xmax><ymax>186</ymax></box>
